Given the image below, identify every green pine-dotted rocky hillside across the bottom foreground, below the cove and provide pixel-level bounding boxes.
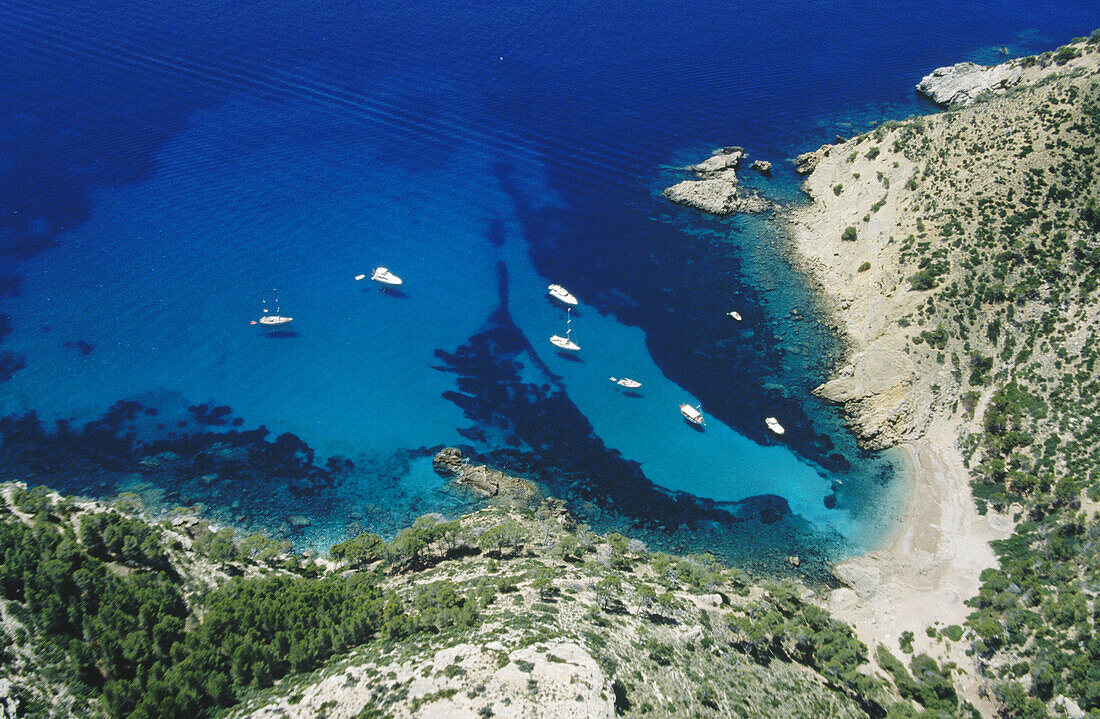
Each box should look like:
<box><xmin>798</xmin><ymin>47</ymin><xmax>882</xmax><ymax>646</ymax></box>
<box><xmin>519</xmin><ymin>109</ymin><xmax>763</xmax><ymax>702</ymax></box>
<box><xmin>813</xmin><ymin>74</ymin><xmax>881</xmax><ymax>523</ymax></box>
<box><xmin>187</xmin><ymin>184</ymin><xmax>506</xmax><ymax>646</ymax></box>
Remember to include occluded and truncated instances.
<box><xmin>0</xmin><ymin>485</ymin><xmax>990</xmax><ymax>719</ymax></box>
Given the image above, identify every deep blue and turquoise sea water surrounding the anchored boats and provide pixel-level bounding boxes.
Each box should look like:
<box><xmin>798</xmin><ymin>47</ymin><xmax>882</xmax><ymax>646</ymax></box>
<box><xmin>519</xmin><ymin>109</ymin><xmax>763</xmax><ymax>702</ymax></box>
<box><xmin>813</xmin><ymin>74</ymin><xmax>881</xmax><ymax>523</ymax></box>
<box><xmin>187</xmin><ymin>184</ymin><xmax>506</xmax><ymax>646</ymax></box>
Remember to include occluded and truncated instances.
<box><xmin>0</xmin><ymin>0</ymin><xmax>1100</xmax><ymax>572</ymax></box>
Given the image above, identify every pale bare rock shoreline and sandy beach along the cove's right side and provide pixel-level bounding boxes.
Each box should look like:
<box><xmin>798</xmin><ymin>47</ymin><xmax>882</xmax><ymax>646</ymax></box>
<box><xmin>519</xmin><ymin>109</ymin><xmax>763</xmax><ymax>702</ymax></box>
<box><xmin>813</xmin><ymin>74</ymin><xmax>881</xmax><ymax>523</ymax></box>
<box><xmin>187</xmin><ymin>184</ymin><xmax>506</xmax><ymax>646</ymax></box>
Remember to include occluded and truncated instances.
<box><xmin>781</xmin><ymin>36</ymin><xmax>1098</xmax><ymax>716</ymax></box>
